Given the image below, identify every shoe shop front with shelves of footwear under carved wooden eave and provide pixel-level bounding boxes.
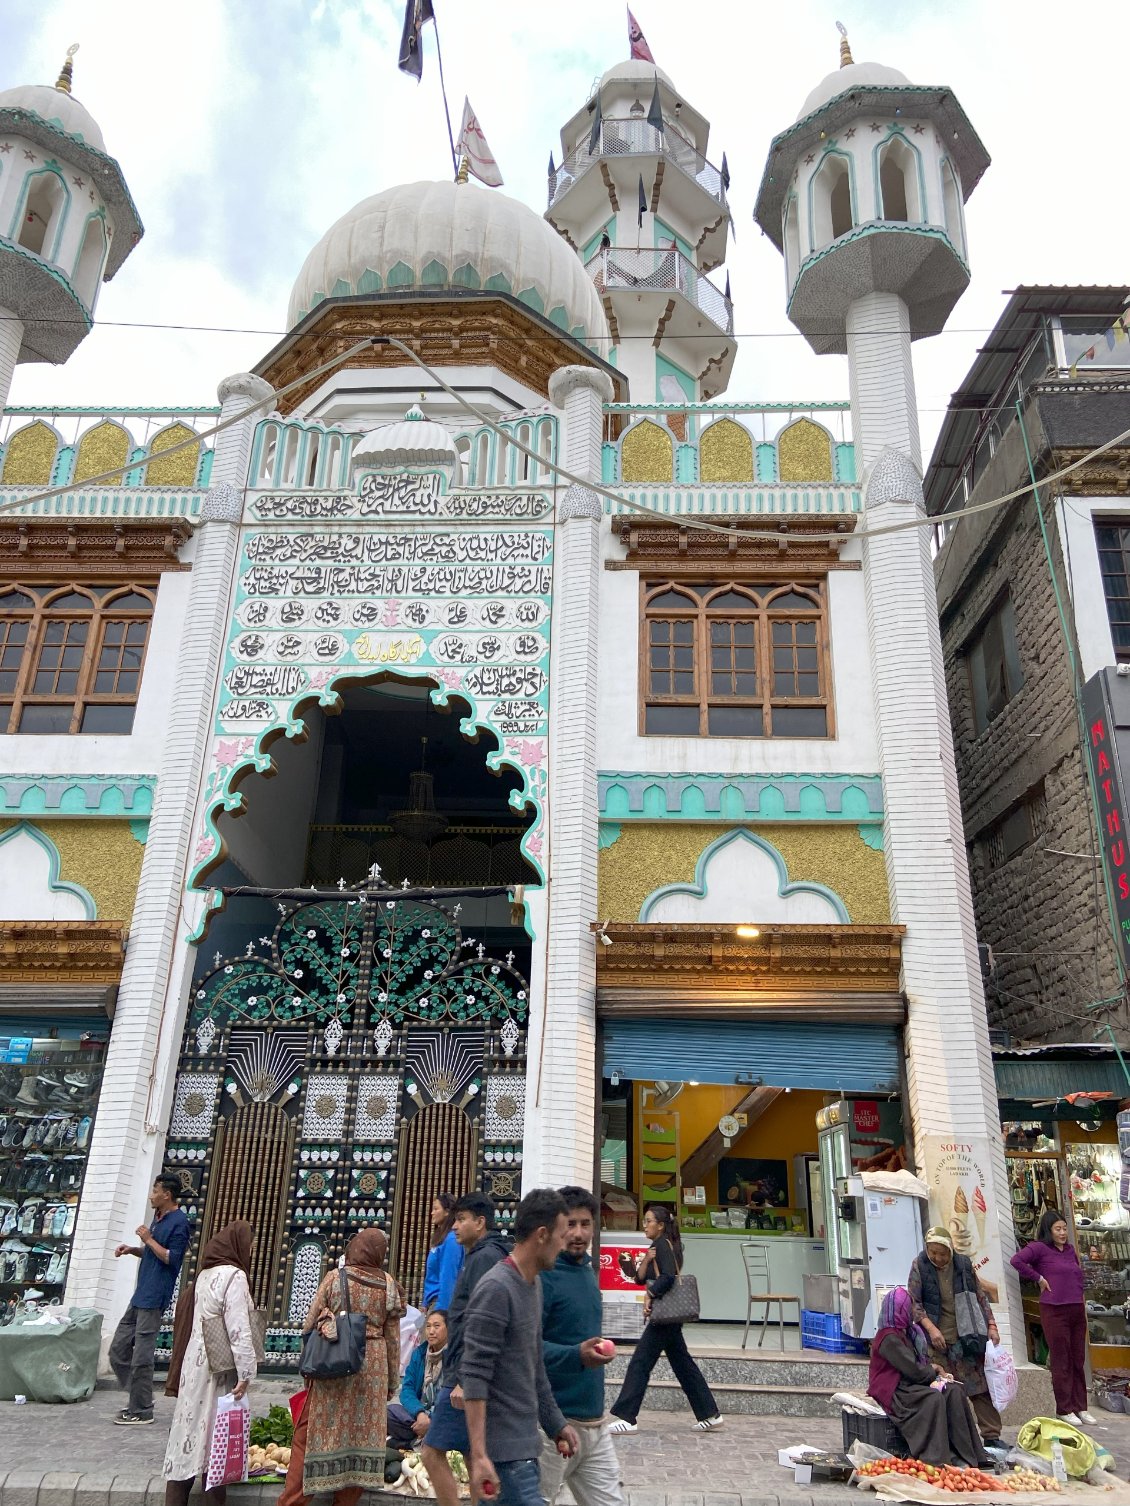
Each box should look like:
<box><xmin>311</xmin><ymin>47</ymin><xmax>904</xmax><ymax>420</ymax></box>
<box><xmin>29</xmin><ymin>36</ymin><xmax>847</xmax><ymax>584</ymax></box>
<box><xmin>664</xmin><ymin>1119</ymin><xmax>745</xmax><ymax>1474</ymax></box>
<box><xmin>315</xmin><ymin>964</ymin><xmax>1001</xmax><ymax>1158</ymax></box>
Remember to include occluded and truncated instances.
<box><xmin>0</xmin><ymin>920</ymin><xmax>124</xmax><ymax>1322</ymax></box>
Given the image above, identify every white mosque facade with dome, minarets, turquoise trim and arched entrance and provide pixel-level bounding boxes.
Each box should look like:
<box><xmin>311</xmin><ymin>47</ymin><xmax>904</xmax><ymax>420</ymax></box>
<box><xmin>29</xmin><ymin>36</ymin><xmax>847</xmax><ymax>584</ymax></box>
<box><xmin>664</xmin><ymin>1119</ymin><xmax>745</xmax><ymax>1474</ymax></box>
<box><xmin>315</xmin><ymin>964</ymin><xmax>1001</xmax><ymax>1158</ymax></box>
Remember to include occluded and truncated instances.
<box><xmin>0</xmin><ymin>38</ymin><xmax>1012</xmax><ymax>1357</ymax></box>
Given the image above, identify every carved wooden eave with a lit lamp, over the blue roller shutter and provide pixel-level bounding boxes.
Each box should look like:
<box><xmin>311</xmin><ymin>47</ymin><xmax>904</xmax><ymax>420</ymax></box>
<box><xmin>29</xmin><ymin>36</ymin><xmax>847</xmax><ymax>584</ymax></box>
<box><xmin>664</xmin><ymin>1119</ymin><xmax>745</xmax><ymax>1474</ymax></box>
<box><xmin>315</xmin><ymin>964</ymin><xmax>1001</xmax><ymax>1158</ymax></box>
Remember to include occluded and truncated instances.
<box><xmin>592</xmin><ymin>922</ymin><xmax>906</xmax><ymax>1024</ymax></box>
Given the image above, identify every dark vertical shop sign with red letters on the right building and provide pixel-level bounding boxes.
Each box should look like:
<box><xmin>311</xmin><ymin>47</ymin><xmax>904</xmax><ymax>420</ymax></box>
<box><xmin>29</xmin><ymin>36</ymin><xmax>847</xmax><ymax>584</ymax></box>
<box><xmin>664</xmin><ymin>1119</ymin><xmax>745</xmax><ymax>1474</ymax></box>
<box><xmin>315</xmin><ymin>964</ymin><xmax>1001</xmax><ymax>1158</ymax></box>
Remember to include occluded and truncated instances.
<box><xmin>1083</xmin><ymin>669</ymin><xmax>1130</xmax><ymax>967</ymax></box>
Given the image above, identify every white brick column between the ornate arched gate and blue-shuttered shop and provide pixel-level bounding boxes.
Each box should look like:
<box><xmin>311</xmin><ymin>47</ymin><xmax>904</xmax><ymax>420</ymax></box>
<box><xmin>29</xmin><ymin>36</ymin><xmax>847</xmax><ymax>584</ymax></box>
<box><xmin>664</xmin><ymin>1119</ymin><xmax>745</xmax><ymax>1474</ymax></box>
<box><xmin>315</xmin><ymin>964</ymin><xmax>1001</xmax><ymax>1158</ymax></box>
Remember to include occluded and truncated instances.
<box><xmin>523</xmin><ymin>366</ymin><xmax>613</xmax><ymax>1188</ymax></box>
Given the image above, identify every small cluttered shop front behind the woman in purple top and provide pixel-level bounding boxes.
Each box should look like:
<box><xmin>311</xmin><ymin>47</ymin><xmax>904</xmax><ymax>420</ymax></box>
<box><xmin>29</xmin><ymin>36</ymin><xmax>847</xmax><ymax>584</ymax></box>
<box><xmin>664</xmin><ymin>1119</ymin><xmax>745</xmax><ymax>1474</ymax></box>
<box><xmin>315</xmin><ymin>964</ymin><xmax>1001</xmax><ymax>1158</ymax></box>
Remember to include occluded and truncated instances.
<box><xmin>993</xmin><ymin>1044</ymin><xmax>1130</xmax><ymax>1369</ymax></box>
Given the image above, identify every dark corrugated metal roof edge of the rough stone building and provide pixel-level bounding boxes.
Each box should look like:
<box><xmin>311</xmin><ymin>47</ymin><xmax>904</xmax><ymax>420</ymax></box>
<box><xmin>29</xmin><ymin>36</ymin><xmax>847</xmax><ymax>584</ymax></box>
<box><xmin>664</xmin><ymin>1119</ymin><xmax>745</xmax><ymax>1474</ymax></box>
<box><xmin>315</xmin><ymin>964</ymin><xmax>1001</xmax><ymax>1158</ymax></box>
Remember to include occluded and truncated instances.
<box><xmin>924</xmin><ymin>285</ymin><xmax>1130</xmax><ymax>517</ymax></box>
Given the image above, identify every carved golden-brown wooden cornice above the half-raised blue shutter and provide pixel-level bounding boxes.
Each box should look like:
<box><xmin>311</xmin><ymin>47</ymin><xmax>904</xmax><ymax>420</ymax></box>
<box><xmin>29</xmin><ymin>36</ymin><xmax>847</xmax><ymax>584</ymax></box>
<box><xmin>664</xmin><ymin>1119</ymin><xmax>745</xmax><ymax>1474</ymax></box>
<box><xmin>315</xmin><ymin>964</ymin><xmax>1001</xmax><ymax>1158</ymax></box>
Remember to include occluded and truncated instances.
<box><xmin>592</xmin><ymin>923</ymin><xmax>906</xmax><ymax>1014</ymax></box>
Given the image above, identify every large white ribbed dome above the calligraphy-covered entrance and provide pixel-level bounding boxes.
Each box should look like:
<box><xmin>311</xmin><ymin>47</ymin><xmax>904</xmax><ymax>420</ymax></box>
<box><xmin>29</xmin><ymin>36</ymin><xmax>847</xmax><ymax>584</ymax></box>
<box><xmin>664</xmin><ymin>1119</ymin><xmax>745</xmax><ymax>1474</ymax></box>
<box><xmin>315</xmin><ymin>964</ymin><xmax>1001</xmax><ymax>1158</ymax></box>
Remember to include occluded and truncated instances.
<box><xmin>286</xmin><ymin>182</ymin><xmax>609</xmax><ymax>340</ymax></box>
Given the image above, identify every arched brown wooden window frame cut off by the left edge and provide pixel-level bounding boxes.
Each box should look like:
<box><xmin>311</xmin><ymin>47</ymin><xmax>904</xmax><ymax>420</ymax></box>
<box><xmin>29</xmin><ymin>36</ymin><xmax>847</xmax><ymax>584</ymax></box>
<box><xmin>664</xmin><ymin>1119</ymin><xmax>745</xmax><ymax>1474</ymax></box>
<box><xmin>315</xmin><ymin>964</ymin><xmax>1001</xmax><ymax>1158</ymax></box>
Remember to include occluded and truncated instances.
<box><xmin>0</xmin><ymin>580</ymin><xmax>157</xmax><ymax>736</ymax></box>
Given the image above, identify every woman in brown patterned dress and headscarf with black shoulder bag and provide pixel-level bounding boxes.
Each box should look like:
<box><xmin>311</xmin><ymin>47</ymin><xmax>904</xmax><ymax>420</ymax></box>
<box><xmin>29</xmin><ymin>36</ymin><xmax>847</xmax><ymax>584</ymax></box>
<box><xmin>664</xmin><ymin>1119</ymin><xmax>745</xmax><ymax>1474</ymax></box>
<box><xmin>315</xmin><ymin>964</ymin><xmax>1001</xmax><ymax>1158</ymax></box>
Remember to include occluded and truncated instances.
<box><xmin>277</xmin><ymin>1229</ymin><xmax>407</xmax><ymax>1506</ymax></box>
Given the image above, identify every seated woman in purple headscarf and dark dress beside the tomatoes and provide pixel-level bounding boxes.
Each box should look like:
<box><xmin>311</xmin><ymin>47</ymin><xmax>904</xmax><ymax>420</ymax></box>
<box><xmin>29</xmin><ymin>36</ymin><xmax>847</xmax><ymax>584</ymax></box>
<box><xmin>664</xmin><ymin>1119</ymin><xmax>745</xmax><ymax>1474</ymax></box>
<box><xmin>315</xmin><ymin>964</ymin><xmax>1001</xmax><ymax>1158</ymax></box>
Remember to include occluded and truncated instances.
<box><xmin>868</xmin><ymin>1286</ymin><xmax>991</xmax><ymax>1468</ymax></box>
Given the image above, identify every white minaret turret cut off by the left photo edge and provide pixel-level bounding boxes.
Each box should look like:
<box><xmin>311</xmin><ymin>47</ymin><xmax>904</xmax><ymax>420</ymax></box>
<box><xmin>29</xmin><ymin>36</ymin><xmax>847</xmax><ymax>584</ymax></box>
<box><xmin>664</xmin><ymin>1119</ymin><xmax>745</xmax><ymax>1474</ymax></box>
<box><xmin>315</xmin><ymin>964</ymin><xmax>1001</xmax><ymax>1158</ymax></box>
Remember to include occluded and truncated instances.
<box><xmin>0</xmin><ymin>45</ymin><xmax>142</xmax><ymax>408</ymax></box>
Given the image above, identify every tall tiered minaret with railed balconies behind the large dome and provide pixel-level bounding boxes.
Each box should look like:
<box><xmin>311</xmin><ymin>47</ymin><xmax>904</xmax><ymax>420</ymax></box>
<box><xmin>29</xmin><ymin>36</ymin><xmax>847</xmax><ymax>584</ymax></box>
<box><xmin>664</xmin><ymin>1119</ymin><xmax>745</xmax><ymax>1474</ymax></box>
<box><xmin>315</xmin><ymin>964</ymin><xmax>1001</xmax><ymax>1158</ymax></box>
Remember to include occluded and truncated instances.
<box><xmin>545</xmin><ymin>59</ymin><xmax>737</xmax><ymax>404</ymax></box>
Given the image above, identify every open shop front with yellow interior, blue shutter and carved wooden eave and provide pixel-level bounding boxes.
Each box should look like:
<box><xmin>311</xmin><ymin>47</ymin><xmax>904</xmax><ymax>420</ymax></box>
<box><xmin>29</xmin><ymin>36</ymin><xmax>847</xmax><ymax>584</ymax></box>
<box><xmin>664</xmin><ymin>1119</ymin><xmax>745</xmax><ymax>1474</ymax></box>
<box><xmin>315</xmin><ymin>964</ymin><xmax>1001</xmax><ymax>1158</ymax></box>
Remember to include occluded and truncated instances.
<box><xmin>597</xmin><ymin>925</ymin><xmax>906</xmax><ymax>1337</ymax></box>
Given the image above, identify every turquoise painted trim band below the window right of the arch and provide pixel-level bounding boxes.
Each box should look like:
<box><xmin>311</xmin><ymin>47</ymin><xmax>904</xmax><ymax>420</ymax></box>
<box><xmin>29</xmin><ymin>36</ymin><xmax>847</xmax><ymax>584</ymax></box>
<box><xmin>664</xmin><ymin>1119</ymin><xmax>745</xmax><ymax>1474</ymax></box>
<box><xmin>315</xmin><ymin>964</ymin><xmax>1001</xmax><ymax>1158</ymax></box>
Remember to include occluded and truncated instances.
<box><xmin>597</xmin><ymin>770</ymin><xmax>883</xmax><ymax>824</ymax></box>
